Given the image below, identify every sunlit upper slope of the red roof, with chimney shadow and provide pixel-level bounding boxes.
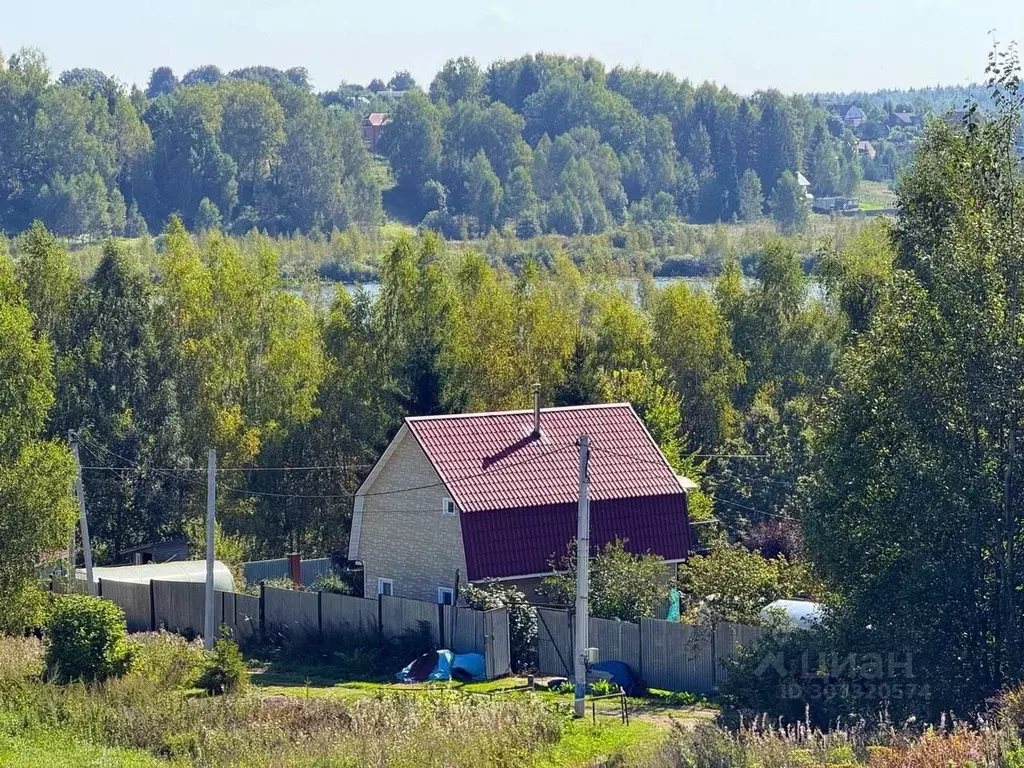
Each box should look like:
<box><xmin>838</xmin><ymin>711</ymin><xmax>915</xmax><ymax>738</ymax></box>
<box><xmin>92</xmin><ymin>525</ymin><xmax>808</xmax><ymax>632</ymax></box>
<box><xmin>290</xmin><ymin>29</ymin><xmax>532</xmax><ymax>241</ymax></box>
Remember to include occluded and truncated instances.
<box><xmin>407</xmin><ymin>403</ymin><xmax>682</xmax><ymax>512</ymax></box>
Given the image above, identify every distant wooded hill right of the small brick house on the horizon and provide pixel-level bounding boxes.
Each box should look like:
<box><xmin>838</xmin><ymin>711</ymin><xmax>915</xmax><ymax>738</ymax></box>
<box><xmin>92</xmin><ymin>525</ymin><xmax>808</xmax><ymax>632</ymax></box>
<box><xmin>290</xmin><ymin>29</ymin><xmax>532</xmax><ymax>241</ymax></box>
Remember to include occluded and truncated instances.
<box><xmin>382</xmin><ymin>54</ymin><xmax>861</xmax><ymax>237</ymax></box>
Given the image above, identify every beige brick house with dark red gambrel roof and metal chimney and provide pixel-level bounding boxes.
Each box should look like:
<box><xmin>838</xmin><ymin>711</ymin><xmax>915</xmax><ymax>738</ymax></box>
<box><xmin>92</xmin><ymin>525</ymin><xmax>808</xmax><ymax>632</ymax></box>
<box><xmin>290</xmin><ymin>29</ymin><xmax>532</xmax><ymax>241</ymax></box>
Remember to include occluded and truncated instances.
<box><xmin>348</xmin><ymin>403</ymin><xmax>695</xmax><ymax>603</ymax></box>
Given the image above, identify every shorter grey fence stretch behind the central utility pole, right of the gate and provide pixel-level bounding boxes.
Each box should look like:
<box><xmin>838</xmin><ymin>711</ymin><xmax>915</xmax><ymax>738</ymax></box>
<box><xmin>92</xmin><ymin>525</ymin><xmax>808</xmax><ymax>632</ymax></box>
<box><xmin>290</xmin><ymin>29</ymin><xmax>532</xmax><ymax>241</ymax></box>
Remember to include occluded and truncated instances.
<box><xmin>537</xmin><ymin>608</ymin><xmax>765</xmax><ymax>693</ymax></box>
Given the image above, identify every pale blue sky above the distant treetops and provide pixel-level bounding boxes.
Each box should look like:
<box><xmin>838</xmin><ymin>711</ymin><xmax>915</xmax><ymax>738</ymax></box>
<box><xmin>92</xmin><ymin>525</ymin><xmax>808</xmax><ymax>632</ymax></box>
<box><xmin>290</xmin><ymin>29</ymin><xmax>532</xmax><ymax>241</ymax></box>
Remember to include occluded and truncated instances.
<box><xmin>0</xmin><ymin>0</ymin><xmax>1024</xmax><ymax>93</ymax></box>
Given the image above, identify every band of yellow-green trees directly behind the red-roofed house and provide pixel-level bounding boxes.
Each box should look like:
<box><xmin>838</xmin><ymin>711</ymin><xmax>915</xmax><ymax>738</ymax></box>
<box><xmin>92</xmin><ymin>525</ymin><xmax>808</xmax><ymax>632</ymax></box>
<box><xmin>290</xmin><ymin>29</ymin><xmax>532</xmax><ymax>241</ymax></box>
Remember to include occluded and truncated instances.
<box><xmin>5</xmin><ymin>210</ymin><xmax>873</xmax><ymax>573</ymax></box>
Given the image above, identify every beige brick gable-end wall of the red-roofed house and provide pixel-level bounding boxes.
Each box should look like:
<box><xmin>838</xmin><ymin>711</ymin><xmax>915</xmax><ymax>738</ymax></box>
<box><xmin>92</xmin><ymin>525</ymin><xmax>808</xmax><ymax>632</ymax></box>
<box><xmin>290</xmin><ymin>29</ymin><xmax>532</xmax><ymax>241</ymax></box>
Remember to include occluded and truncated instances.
<box><xmin>358</xmin><ymin>426</ymin><xmax>466</xmax><ymax>601</ymax></box>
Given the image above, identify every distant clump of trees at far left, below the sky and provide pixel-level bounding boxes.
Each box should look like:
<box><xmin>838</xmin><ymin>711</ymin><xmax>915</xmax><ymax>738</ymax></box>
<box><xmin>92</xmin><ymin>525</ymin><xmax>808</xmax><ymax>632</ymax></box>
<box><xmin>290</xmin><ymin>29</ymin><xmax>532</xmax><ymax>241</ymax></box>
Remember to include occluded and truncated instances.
<box><xmin>0</xmin><ymin>50</ymin><xmax>384</xmax><ymax>237</ymax></box>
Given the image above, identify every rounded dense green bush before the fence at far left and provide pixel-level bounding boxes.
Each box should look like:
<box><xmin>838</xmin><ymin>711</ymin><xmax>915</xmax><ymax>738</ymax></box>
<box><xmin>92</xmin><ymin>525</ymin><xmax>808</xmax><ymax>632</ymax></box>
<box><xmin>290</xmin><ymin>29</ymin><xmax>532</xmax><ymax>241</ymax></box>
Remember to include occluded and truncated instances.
<box><xmin>45</xmin><ymin>595</ymin><xmax>131</xmax><ymax>682</ymax></box>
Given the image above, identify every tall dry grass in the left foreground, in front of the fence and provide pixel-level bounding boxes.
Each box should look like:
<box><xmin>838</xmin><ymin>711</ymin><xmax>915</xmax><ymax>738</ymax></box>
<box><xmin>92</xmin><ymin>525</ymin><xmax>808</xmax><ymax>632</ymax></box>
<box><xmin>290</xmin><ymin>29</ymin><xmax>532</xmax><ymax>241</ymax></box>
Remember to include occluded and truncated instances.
<box><xmin>0</xmin><ymin>636</ymin><xmax>566</xmax><ymax>768</ymax></box>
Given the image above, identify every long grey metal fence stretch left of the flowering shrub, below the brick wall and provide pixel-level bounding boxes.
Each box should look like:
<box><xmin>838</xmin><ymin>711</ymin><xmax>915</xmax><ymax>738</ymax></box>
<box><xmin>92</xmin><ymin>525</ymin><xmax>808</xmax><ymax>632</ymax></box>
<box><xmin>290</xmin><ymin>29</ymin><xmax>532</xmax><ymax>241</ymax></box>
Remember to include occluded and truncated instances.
<box><xmin>86</xmin><ymin>580</ymin><xmax>510</xmax><ymax>679</ymax></box>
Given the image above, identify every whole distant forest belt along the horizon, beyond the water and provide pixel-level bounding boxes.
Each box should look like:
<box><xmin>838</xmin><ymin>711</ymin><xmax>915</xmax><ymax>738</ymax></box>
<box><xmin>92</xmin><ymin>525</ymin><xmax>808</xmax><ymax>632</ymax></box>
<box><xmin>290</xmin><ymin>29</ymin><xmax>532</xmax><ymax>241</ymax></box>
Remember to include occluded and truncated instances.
<box><xmin>0</xmin><ymin>50</ymin><xmax>942</xmax><ymax>239</ymax></box>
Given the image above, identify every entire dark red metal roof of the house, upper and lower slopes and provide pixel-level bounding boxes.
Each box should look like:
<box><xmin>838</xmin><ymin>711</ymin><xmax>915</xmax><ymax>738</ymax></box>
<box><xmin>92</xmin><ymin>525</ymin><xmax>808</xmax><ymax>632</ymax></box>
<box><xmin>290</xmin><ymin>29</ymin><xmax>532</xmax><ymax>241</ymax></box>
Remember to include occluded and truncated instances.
<box><xmin>407</xmin><ymin>403</ymin><xmax>691</xmax><ymax>581</ymax></box>
